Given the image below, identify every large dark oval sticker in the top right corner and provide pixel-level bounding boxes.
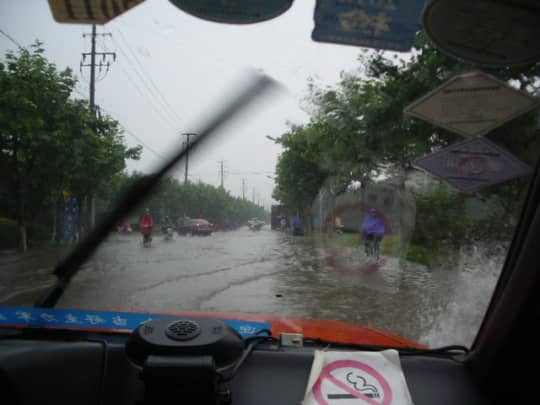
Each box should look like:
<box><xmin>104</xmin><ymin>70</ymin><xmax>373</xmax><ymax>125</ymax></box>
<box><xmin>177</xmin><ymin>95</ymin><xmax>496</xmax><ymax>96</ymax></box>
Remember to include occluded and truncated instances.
<box><xmin>423</xmin><ymin>0</ymin><xmax>540</xmax><ymax>67</ymax></box>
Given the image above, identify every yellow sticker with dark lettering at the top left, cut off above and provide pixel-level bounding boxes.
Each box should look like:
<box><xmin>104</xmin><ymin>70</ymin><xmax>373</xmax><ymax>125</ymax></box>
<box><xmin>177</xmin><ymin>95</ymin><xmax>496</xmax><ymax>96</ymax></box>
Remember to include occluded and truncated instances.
<box><xmin>49</xmin><ymin>0</ymin><xmax>144</xmax><ymax>25</ymax></box>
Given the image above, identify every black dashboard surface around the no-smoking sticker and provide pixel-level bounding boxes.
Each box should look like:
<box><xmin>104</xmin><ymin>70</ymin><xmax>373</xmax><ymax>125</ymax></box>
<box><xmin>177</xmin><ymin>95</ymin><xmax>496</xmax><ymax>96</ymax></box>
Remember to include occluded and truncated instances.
<box><xmin>0</xmin><ymin>329</ymin><xmax>489</xmax><ymax>405</ymax></box>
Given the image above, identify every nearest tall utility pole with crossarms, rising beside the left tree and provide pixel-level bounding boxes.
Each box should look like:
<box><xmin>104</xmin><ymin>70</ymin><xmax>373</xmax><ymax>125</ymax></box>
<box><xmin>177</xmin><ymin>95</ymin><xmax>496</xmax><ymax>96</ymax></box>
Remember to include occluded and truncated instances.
<box><xmin>80</xmin><ymin>24</ymin><xmax>116</xmax><ymax>228</ymax></box>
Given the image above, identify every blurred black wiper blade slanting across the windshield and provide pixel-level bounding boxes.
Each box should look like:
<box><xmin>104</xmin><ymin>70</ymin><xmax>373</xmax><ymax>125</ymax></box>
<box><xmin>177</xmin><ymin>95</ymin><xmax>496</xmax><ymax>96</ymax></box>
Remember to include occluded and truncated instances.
<box><xmin>34</xmin><ymin>75</ymin><xmax>277</xmax><ymax>308</ymax></box>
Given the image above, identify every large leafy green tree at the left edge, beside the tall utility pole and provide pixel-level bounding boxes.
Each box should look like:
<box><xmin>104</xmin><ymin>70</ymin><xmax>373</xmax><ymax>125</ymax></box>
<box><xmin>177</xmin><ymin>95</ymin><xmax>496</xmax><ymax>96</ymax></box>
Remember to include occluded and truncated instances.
<box><xmin>0</xmin><ymin>42</ymin><xmax>140</xmax><ymax>250</ymax></box>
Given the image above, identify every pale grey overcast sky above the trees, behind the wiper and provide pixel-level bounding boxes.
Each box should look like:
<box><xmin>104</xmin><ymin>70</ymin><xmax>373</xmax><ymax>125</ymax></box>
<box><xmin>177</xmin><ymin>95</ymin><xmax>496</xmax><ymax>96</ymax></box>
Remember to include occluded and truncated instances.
<box><xmin>0</xmin><ymin>0</ymin><xmax>368</xmax><ymax>207</ymax></box>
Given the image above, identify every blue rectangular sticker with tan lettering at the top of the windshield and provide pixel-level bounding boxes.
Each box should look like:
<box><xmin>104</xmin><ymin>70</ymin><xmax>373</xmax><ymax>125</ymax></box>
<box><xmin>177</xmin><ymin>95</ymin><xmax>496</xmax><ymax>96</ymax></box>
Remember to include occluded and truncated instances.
<box><xmin>312</xmin><ymin>0</ymin><xmax>424</xmax><ymax>52</ymax></box>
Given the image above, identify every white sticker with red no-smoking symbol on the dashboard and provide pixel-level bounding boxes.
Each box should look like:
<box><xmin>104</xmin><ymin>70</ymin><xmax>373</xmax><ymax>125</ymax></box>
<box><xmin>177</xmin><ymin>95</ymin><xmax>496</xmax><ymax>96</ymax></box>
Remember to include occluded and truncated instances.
<box><xmin>303</xmin><ymin>350</ymin><xmax>412</xmax><ymax>405</ymax></box>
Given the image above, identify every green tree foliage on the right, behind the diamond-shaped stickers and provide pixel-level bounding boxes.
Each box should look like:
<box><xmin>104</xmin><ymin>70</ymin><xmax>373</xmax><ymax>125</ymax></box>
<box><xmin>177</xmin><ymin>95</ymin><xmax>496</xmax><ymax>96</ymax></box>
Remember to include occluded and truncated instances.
<box><xmin>274</xmin><ymin>31</ymin><xmax>540</xmax><ymax>258</ymax></box>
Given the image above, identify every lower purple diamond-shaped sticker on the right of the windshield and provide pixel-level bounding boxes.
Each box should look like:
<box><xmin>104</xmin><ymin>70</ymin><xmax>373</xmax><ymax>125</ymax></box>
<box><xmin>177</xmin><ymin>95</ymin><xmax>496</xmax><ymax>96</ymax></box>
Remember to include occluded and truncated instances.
<box><xmin>413</xmin><ymin>138</ymin><xmax>532</xmax><ymax>192</ymax></box>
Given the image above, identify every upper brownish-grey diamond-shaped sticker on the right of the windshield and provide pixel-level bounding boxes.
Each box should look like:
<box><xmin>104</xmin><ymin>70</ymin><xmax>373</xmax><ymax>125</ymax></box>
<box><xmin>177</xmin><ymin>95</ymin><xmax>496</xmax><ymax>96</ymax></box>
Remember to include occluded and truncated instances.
<box><xmin>405</xmin><ymin>72</ymin><xmax>538</xmax><ymax>137</ymax></box>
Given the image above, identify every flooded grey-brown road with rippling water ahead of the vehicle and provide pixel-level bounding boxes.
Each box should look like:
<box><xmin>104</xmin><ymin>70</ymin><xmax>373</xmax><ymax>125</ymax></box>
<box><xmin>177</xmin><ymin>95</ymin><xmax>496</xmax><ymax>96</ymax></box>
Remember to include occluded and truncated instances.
<box><xmin>0</xmin><ymin>228</ymin><xmax>502</xmax><ymax>346</ymax></box>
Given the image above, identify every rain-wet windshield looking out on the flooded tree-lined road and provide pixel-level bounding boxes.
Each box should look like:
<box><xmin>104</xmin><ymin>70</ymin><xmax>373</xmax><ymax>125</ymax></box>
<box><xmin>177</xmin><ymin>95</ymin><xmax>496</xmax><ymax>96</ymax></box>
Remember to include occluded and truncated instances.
<box><xmin>0</xmin><ymin>0</ymin><xmax>540</xmax><ymax>346</ymax></box>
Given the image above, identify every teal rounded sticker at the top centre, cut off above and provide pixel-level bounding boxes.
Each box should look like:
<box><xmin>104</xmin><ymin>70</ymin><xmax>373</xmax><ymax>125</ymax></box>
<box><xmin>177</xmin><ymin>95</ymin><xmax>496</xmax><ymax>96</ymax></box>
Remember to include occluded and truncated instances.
<box><xmin>170</xmin><ymin>0</ymin><xmax>293</xmax><ymax>24</ymax></box>
